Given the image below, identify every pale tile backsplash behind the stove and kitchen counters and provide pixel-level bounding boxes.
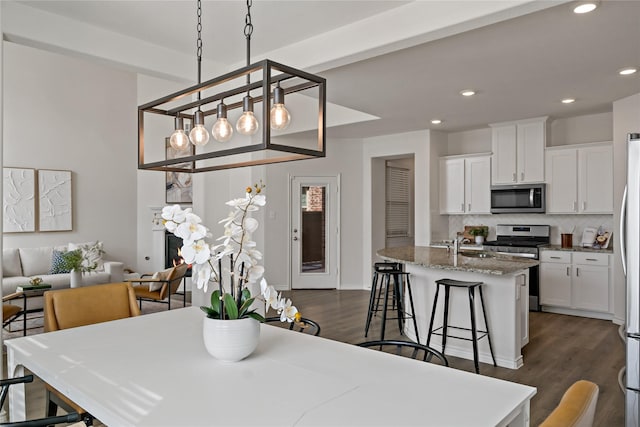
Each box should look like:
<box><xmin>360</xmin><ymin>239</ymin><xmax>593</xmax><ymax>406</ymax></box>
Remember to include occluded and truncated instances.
<box><xmin>448</xmin><ymin>214</ymin><xmax>616</xmax><ymax>249</ymax></box>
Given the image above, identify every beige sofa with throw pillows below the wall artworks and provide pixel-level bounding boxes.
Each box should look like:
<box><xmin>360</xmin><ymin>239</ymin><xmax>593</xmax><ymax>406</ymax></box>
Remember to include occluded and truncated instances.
<box><xmin>2</xmin><ymin>246</ymin><xmax>132</xmax><ymax>308</ymax></box>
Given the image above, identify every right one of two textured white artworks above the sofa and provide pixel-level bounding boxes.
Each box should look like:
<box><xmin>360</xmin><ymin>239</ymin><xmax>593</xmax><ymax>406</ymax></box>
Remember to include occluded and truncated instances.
<box><xmin>38</xmin><ymin>170</ymin><xmax>72</xmax><ymax>231</ymax></box>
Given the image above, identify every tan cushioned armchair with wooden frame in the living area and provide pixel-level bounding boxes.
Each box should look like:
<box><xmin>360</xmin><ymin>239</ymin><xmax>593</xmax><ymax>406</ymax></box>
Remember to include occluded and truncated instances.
<box><xmin>129</xmin><ymin>264</ymin><xmax>189</xmax><ymax>310</ymax></box>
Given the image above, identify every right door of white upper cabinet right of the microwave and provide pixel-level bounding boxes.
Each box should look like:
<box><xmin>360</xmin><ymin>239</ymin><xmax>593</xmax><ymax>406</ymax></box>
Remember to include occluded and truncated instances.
<box><xmin>578</xmin><ymin>145</ymin><xmax>613</xmax><ymax>214</ymax></box>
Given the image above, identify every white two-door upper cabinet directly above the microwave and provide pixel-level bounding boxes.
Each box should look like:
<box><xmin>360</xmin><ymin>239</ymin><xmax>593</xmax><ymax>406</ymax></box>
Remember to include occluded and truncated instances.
<box><xmin>490</xmin><ymin>117</ymin><xmax>547</xmax><ymax>185</ymax></box>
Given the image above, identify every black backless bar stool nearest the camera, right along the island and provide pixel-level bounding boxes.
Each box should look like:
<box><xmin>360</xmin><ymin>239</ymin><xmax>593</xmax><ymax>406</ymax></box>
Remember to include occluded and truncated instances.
<box><xmin>427</xmin><ymin>279</ymin><xmax>497</xmax><ymax>374</ymax></box>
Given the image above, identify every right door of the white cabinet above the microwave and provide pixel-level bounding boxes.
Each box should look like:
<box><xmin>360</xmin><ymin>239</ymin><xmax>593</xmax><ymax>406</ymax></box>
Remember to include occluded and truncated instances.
<box><xmin>516</xmin><ymin>122</ymin><xmax>546</xmax><ymax>183</ymax></box>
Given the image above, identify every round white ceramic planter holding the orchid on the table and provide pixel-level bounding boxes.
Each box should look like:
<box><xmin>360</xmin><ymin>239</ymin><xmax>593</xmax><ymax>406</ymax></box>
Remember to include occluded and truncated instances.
<box><xmin>202</xmin><ymin>317</ymin><xmax>260</xmax><ymax>362</ymax></box>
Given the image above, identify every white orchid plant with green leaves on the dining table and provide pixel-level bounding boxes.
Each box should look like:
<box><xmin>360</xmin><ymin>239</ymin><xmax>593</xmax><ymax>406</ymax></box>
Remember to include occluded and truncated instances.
<box><xmin>162</xmin><ymin>182</ymin><xmax>300</xmax><ymax>322</ymax></box>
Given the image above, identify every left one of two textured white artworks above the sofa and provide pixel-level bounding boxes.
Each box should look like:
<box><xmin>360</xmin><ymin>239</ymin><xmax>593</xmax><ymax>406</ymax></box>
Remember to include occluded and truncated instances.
<box><xmin>2</xmin><ymin>168</ymin><xmax>36</xmax><ymax>233</ymax></box>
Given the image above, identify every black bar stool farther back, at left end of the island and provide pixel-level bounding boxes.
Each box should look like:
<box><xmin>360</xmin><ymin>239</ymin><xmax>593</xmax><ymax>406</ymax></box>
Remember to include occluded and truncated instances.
<box><xmin>364</xmin><ymin>262</ymin><xmax>420</xmax><ymax>342</ymax></box>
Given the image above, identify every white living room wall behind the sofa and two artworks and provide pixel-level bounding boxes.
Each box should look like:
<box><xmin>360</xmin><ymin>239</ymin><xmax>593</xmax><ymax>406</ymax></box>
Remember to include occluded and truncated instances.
<box><xmin>3</xmin><ymin>42</ymin><xmax>137</xmax><ymax>266</ymax></box>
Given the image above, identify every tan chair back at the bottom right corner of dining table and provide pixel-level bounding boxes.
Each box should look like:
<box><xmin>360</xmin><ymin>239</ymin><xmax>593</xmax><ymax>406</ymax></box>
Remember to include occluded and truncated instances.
<box><xmin>540</xmin><ymin>380</ymin><xmax>600</xmax><ymax>427</ymax></box>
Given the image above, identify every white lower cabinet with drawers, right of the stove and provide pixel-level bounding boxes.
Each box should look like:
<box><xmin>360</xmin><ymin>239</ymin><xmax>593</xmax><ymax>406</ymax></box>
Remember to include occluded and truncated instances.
<box><xmin>540</xmin><ymin>251</ymin><xmax>611</xmax><ymax>317</ymax></box>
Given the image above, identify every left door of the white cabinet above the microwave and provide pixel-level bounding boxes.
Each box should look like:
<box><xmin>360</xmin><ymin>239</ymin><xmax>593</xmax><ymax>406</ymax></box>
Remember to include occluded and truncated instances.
<box><xmin>491</xmin><ymin>125</ymin><xmax>517</xmax><ymax>184</ymax></box>
